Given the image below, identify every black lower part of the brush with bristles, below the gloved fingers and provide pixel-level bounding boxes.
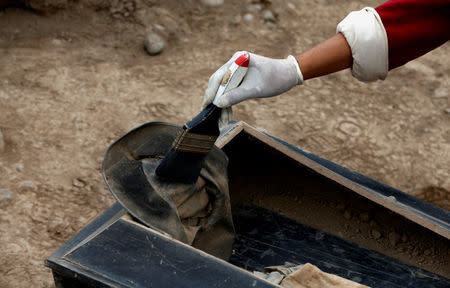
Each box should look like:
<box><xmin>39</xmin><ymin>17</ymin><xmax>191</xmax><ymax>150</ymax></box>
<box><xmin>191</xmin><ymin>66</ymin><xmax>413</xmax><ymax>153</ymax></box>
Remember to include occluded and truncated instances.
<box><xmin>155</xmin><ymin>104</ymin><xmax>222</xmax><ymax>184</ymax></box>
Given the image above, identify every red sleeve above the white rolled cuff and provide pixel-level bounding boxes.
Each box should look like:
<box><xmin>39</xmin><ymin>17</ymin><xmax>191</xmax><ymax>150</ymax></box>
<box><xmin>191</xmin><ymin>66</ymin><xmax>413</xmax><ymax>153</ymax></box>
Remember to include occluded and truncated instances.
<box><xmin>375</xmin><ymin>0</ymin><xmax>450</xmax><ymax>69</ymax></box>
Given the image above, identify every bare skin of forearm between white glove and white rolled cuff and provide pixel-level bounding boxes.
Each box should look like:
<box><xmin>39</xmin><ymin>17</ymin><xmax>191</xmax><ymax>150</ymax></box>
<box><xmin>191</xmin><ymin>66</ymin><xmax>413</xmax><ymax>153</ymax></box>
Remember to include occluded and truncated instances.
<box><xmin>295</xmin><ymin>33</ymin><xmax>353</xmax><ymax>80</ymax></box>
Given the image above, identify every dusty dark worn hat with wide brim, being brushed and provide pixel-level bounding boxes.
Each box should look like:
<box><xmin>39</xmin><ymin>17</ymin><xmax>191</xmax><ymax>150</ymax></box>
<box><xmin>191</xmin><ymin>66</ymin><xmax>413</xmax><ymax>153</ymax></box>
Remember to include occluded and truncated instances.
<box><xmin>103</xmin><ymin>122</ymin><xmax>234</xmax><ymax>260</ymax></box>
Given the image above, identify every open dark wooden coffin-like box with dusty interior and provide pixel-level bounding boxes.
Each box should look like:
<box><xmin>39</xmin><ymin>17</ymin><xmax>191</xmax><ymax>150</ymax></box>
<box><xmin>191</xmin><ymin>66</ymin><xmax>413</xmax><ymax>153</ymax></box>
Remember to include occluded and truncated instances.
<box><xmin>46</xmin><ymin>122</ymin><xmax>450</xmax><ymax>288</ymax></box>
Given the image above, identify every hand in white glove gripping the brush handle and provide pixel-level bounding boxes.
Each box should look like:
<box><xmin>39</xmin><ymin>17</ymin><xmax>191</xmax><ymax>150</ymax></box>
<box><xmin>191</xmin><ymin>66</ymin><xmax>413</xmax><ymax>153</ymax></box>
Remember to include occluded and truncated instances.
<box><xmin>202</xmin><ymin>51</ymin><xmax>303</xmax><ymax>108</ymax></box>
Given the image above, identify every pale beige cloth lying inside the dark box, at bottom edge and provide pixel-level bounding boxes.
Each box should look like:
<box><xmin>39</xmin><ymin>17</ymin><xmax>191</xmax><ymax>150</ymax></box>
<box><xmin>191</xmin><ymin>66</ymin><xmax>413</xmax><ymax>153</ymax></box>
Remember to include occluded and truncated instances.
<box><xmin>253</xmin><ymin>262</ymin><xmax>369</xmax><ymax>288</ymax></box>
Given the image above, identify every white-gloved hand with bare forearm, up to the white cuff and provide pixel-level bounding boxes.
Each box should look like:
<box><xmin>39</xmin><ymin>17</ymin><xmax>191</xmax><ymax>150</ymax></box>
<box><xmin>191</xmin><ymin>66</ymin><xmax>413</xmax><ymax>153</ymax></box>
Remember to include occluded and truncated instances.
<box><xmin>203</xmin><ymin>33</ymin><xmax>352</xmax><ymax>108</ymax></box>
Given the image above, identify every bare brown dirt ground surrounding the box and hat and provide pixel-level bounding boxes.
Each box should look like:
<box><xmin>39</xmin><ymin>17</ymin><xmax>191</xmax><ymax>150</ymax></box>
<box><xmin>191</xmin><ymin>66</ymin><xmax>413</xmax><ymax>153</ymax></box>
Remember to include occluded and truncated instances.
<box><xmin>0</xmin><ymin>0</ymin><xmax>450</xmax><ymax>287</ymax></box>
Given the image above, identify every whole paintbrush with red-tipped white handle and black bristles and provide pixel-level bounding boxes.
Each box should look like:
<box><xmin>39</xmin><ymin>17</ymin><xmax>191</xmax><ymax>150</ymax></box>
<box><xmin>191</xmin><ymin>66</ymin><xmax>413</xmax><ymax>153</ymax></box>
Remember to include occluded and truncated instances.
<box><xmin>155</xmin><ymin>53</ymin><xmax>250</xmax><ymax>184</ymax></box>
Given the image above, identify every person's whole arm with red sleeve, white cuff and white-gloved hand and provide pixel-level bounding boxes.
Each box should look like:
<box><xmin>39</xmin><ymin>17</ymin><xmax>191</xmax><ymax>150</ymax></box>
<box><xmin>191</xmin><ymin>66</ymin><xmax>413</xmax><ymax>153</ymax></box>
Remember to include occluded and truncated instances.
<box><xmin>203</xmin><ymin>0</ymin><xmax>450</xmax><ymax>108</ymax></box>
